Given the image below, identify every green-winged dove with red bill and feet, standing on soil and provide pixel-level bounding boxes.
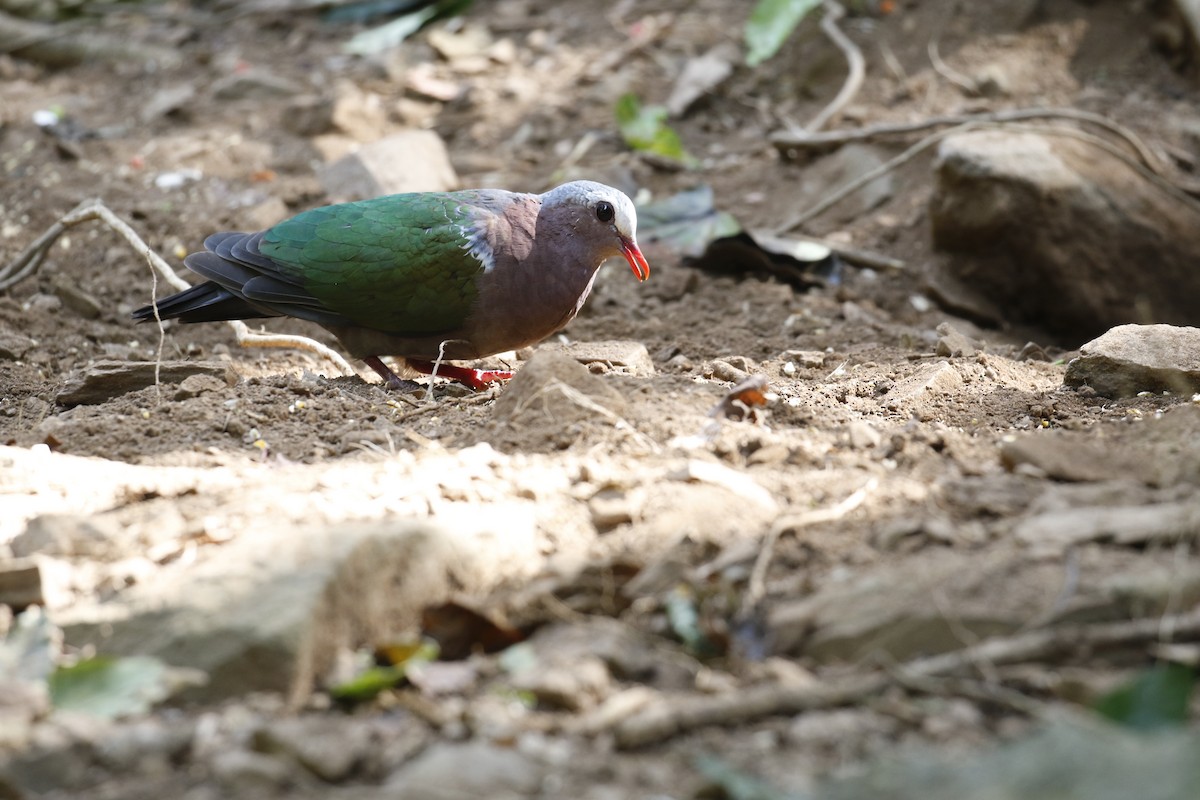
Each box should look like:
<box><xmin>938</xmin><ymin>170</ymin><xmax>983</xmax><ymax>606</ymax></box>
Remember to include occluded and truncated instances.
<box><xmin>133</xmin><ymin>181</ymin><xmax>650</xmax><ymax>390</ymax></box>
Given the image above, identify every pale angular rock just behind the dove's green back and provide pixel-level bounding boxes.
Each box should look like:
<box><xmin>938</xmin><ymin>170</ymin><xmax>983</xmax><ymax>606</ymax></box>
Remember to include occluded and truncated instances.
<box><xmin>319</xmin><ymin>131</ymin><xmax>458</xmax><ymax>200</ymax></box>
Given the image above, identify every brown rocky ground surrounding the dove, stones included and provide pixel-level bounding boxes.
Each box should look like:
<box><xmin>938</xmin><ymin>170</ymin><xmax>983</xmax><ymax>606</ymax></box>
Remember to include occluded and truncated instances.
<box><xmin>0</xmin><ymin>0</ymin><xmax>1200</xmax><ymax>800</ymax></box>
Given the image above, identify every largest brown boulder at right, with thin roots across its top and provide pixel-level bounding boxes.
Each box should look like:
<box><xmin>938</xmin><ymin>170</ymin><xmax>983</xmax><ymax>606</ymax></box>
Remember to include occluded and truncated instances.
<box><xmin>930</xmin><ymin>131</ymin><xmax>1200</xmax><ymax>342</ymax></box>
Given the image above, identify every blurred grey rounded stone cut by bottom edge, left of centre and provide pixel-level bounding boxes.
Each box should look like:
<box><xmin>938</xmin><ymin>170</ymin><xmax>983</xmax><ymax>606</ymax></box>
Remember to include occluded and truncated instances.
<box><xmin>385</xmin><ymin>741</ymin><xmax>546</xmax><ymax>800</ymax></box>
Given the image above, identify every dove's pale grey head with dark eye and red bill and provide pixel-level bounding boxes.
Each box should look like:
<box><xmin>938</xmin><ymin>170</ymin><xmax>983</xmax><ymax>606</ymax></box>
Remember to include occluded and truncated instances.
<box><xmin>541</xmin><ymin>181</ymin><xmax>650</xmax><ymax>281</ymax></box>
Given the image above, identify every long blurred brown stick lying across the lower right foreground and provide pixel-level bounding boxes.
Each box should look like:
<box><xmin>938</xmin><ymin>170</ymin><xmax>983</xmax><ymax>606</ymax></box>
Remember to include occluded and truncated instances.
<box><xmin>612</xmin><ymin>608</ymin><xmax>1200</xmax><ymax>747</ymax></box>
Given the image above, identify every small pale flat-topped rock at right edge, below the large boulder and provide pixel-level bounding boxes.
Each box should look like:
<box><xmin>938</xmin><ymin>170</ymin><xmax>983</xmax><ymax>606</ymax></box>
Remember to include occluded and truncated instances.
<box><xmin>1063</xmin><ymin>325</ymin><xmax>1200</xmax><ymax>397</ymax></box>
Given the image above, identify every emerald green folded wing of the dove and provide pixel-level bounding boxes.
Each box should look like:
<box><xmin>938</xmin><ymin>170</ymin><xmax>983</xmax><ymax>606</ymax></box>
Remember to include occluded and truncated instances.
<box><xmin>258</xmin><ymin>192</ymin><xmax>491</xmax><ymax>335</ymax></box>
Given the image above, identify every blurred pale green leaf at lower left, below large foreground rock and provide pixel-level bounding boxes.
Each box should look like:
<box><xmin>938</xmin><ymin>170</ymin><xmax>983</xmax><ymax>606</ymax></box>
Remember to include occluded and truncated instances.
<box><xmin>49</xmin><ymin>656</ymin><xmax>203</xmax><ymax>720</ymax></box>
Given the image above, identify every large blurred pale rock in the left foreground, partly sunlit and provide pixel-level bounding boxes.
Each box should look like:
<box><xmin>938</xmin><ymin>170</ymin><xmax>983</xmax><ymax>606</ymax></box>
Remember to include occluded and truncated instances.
<box><xmin>56</xmin><ymin>515</ymin><xmax>539</xmax><ymax>700</ymax></box>
